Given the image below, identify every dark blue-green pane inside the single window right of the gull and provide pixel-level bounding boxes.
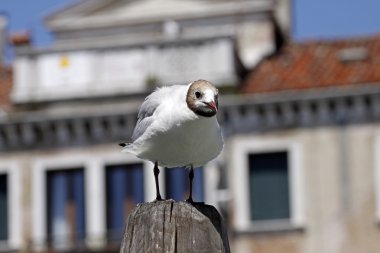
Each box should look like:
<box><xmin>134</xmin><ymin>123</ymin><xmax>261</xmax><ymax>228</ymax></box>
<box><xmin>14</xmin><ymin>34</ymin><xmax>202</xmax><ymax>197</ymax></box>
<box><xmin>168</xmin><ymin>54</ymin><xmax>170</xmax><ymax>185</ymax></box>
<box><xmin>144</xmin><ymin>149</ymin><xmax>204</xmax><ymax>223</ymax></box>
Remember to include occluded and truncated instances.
<box><xmin>248</xmin><ymin>152</ymin><xmax>290</xmax><ymax>220</ymax></box>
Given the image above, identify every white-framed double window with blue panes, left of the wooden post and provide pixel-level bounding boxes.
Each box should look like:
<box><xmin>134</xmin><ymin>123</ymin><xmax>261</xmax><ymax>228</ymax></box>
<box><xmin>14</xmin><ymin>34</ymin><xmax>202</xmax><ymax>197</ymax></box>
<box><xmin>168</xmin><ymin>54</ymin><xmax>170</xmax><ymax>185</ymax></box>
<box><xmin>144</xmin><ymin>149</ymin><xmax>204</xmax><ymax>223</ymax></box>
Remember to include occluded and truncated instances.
<box><xmin>31</xmin><ymin>153</ymin><xmax>150</xmax><ymax>252</ymax></box>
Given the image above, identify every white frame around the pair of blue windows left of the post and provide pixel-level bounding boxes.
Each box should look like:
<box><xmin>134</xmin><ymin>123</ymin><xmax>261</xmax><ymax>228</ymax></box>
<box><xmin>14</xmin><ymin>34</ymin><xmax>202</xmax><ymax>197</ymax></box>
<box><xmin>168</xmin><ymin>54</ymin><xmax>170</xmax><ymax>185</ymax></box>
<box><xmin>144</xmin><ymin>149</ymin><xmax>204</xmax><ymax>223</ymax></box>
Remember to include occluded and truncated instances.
<box><xmin>32</xmin><ymin>151</ymin><xmax>151</xmax><ymax>250</ymax></box>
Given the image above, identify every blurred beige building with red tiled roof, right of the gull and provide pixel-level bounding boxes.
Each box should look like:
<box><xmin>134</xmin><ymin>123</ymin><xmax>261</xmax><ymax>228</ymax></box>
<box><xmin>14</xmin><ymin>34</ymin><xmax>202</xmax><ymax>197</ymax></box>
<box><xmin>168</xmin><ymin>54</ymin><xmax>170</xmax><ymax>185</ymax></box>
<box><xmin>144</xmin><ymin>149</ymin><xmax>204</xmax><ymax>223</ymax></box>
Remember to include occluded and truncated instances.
<box><xmin>224</xmin><ymin>36</ymin><xmax>380</xmax><ymax>253</ymax></box>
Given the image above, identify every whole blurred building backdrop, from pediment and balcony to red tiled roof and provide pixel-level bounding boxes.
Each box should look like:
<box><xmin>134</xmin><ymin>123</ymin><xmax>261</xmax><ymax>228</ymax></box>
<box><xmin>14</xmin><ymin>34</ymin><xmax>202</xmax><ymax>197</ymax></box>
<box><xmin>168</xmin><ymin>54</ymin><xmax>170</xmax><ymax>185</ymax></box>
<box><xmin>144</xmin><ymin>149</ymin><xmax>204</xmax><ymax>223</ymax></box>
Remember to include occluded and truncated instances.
<box><xmin>5</xmin><ymin>0</ymin><xmax>380</xmax><ymax>253</ymax></box>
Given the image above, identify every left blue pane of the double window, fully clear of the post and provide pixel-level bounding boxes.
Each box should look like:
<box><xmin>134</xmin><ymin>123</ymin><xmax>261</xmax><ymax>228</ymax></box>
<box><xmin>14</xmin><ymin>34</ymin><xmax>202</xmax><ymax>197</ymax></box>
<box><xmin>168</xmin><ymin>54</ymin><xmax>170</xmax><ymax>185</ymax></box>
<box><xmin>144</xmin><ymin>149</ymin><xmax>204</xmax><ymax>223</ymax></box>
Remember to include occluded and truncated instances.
<box><xmin>46</xmin><ymin>169</ymin><xmax>85</xmax><ymax>248</ymax></box>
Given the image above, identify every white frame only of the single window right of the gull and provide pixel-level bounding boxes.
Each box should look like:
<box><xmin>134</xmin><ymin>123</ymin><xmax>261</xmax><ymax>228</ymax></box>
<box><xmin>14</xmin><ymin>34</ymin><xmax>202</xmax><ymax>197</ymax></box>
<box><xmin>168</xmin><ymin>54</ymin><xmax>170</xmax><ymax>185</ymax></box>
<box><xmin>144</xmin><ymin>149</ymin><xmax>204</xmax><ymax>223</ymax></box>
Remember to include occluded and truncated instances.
<box><xmin>229</xmin><ymin>136</ymin><xmax>305</xmax><ymax>232</ymax></box>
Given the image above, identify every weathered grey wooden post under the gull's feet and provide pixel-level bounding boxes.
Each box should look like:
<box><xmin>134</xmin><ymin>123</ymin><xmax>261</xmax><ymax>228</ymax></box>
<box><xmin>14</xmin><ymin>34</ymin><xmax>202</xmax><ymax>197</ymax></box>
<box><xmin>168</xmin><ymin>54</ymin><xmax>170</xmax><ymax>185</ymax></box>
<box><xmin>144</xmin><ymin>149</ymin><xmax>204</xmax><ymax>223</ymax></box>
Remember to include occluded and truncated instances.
<box><xmin>120</xmin><ymin>200</ymin><xmax>230</xmax><ymax>253</ymax></box>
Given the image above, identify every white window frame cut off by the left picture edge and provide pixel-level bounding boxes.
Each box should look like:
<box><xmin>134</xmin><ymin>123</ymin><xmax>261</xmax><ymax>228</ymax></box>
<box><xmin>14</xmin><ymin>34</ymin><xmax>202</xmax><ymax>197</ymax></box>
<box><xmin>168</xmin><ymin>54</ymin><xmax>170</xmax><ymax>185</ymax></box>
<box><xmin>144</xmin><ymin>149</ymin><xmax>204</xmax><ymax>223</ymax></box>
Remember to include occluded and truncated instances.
<box><xmin>0</xmin><ymin>162</ymin><xmax>23</xmax><ymax>252</ymax></box>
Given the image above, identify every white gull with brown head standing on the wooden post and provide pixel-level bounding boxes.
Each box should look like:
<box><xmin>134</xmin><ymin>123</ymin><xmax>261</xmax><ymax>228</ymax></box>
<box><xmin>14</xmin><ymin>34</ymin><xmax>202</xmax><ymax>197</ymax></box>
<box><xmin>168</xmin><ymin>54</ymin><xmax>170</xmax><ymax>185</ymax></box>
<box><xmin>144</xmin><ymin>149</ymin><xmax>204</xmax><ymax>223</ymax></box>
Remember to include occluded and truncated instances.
<box><xmin>119</xmin><ymin>80</ymin><xmax>223</xmax><ymax>203</ymax></box>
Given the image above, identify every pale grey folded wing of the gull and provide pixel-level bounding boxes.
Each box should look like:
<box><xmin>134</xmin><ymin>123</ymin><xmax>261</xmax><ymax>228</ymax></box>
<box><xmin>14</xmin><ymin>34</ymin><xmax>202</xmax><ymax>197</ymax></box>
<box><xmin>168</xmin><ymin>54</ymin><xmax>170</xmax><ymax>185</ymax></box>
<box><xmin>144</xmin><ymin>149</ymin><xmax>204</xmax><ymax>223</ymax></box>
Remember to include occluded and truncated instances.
<box><xmin>132</xmin><ymin>90</ymin><xmax>161</xmax><ymax>142</ymax></box>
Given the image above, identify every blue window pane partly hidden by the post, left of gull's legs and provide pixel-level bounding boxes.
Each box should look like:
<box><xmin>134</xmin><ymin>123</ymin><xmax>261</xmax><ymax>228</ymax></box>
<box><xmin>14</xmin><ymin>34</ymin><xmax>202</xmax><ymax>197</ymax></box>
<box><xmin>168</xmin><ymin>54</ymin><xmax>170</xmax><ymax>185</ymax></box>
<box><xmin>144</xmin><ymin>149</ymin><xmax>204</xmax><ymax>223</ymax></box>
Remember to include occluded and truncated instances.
<box><xmin>106</xmin><ymin>163</ymin><xmax>144</xmax><ymax>243</ymax></box>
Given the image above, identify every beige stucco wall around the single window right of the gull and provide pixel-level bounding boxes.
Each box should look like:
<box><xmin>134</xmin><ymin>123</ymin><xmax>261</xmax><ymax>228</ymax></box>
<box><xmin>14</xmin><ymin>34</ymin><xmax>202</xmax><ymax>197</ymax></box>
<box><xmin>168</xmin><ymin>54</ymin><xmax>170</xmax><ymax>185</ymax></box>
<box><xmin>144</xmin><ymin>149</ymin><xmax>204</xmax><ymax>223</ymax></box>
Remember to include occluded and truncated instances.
<box><xmin>225</xmin><ymin>125</ymin><xmax>380</xmax><ymax>253</ymax></box>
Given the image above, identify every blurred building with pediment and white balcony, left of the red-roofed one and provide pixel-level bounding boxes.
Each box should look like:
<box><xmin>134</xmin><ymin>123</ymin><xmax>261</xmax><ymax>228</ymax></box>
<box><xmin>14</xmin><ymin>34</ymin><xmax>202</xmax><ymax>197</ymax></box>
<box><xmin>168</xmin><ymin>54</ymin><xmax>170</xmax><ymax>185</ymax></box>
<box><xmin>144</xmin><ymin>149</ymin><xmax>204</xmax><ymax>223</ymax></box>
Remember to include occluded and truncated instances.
<box><xmin>0</xmin><ymin>0</ymin><xmax>290</xmax><ymax>252</ymax></box>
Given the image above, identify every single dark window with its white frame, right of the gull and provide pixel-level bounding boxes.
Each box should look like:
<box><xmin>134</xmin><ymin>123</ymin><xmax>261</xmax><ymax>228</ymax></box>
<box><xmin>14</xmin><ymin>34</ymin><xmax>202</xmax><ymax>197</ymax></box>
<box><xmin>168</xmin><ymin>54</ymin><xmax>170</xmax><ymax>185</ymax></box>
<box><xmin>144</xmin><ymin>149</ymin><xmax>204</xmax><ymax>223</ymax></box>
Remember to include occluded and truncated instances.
<box><xmin>228</xmin><ymin>136</ymin><xmax>305</xmax><ymax>232</ymax></box>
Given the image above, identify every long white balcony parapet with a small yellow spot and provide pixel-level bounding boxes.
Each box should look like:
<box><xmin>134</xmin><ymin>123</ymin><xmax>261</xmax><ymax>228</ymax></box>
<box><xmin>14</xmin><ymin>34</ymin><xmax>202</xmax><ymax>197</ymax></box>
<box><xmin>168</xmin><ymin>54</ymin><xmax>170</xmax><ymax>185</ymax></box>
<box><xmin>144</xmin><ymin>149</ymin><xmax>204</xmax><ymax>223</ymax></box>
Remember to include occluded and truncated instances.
<box><xmin>12</xmin><ymin>38</ymin><xmax>236</xmax><ymax>103</ymax></box>
